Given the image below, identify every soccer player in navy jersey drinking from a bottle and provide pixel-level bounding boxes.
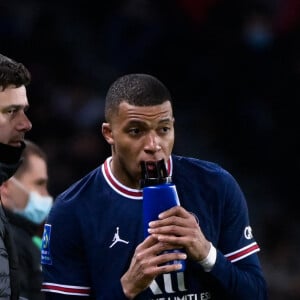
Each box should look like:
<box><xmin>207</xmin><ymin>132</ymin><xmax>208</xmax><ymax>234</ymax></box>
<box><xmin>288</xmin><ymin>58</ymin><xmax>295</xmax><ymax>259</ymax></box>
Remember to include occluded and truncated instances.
<box><xmin>42</xmin><ymin>74</ymin><xmax>267</xmax><ymax>300</ymax></box>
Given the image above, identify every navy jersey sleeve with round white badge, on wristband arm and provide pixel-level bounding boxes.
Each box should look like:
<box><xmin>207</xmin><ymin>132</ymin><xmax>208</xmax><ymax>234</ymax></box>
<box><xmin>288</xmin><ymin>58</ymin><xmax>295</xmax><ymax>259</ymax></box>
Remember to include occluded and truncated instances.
<box><xmin>211</xmin><ymin>173</ymin><xmax>267</xmax><ymax>300</ymax></box>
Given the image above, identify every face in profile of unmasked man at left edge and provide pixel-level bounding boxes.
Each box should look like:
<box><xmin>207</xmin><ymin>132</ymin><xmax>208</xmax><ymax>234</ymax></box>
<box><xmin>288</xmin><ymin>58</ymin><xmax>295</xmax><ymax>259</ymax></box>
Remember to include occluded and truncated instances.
<box><xmin>0</xmin><ymin>86</ymin><xmax>32</xmax><ymax>147</ymax></box>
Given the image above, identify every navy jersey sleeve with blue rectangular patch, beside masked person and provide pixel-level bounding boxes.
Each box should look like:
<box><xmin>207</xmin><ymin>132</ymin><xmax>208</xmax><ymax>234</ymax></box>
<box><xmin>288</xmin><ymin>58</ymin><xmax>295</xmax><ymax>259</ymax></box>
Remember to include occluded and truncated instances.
<box><xmin>41</xmin><ymin>199</ymin><xmax>91</xmax><ymax>299</ymax></box>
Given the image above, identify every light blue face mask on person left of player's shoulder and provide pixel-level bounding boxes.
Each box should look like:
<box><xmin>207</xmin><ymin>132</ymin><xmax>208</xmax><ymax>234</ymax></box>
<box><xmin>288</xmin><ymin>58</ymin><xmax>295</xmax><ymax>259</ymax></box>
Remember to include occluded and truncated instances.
<box><xmin>14</xmin><ymin>191</ymin><xmax>53</xmax><ymax>224</ymax></box>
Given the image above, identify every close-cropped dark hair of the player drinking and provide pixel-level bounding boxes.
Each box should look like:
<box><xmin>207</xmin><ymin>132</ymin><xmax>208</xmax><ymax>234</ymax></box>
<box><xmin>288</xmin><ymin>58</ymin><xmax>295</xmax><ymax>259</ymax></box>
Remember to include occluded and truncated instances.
<box><xmin>105</xmin><ymin>74</ymin><xmax>172</xmax><ymax>122</ymax></box>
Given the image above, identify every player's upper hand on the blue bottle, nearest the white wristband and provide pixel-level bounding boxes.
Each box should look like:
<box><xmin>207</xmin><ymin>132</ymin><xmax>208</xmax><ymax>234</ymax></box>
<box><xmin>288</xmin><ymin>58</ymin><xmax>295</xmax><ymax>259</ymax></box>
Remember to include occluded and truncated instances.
<box><xmin>149</xmin><ymin>206</ymin><xmax>210</xmax><ymax>261</ymax></box>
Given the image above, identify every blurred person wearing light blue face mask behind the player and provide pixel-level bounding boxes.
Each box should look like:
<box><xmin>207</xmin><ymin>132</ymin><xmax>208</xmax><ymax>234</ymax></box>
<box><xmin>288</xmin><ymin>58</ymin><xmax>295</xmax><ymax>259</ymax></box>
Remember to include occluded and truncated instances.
<box><xmin>0</xmin><ymin>140</ymin><xmax>53</xmax><ymax>300</ymax></box>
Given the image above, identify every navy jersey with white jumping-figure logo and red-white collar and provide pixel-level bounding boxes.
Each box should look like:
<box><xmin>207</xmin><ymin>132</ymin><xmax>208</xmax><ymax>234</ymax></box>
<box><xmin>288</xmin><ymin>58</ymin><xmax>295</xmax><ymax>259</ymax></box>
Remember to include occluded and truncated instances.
<box><xmin>42</xmin><ymin>155</ymin><xmax>266</xmax><ymax>300</ymax></box>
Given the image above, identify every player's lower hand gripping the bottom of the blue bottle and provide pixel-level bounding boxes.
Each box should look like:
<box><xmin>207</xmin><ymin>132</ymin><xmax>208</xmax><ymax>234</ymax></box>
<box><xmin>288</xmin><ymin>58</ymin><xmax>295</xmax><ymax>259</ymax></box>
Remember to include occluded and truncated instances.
<box><xmin>121</xmin><ymin>235</ymin><xmax>186</xmax><ymax>299</ymax></box>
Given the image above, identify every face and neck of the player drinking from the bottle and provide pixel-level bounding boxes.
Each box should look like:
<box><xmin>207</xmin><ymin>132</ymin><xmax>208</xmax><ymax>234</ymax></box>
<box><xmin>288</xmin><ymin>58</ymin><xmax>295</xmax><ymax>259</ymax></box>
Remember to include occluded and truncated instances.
<box><xmin>102</xmin><ymin>101</ymin><xmax>174</xmax><ymax>188</ymax></box>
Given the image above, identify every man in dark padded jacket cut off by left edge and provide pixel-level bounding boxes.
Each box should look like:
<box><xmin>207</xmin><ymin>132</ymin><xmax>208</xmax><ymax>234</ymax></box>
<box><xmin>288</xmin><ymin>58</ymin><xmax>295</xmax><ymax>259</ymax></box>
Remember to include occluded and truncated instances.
<box><xmin>0</xmin><ymin>54</ymin><xmax>32</xmax><ymax>300</ymax></box>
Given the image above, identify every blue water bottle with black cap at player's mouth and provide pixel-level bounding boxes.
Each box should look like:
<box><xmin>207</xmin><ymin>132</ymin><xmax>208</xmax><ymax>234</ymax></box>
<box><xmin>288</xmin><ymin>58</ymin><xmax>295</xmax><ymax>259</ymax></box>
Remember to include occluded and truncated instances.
<box><xmin>141</xmin><ymin>159</ymin><xmax>185</xmax><ymax>272</ymax></box>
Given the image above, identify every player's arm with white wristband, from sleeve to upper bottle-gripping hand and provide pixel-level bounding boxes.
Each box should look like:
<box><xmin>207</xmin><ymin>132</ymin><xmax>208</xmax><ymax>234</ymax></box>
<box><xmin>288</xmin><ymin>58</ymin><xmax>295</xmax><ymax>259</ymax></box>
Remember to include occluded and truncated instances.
<box><xmin>150</xmin><ymin>172</ymin><xmax>267</xmax><ymax>300</ymax></box>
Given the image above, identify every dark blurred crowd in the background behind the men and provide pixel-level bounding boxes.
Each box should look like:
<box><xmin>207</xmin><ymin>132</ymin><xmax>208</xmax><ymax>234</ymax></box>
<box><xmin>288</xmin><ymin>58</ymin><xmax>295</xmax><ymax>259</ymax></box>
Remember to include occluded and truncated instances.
<box><xmin>0</xmin><ymin>0</ymin><xmax>300</xmax><ymax>300</ymax></box>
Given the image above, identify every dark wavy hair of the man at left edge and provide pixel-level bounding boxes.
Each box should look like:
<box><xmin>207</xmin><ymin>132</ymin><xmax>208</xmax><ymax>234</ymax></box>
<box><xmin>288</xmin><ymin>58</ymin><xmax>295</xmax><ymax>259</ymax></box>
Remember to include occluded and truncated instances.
<box><xmin>0</xmin><ymin>54</ymin><xmax>31</xmax><ymax>91</ymax></box>
